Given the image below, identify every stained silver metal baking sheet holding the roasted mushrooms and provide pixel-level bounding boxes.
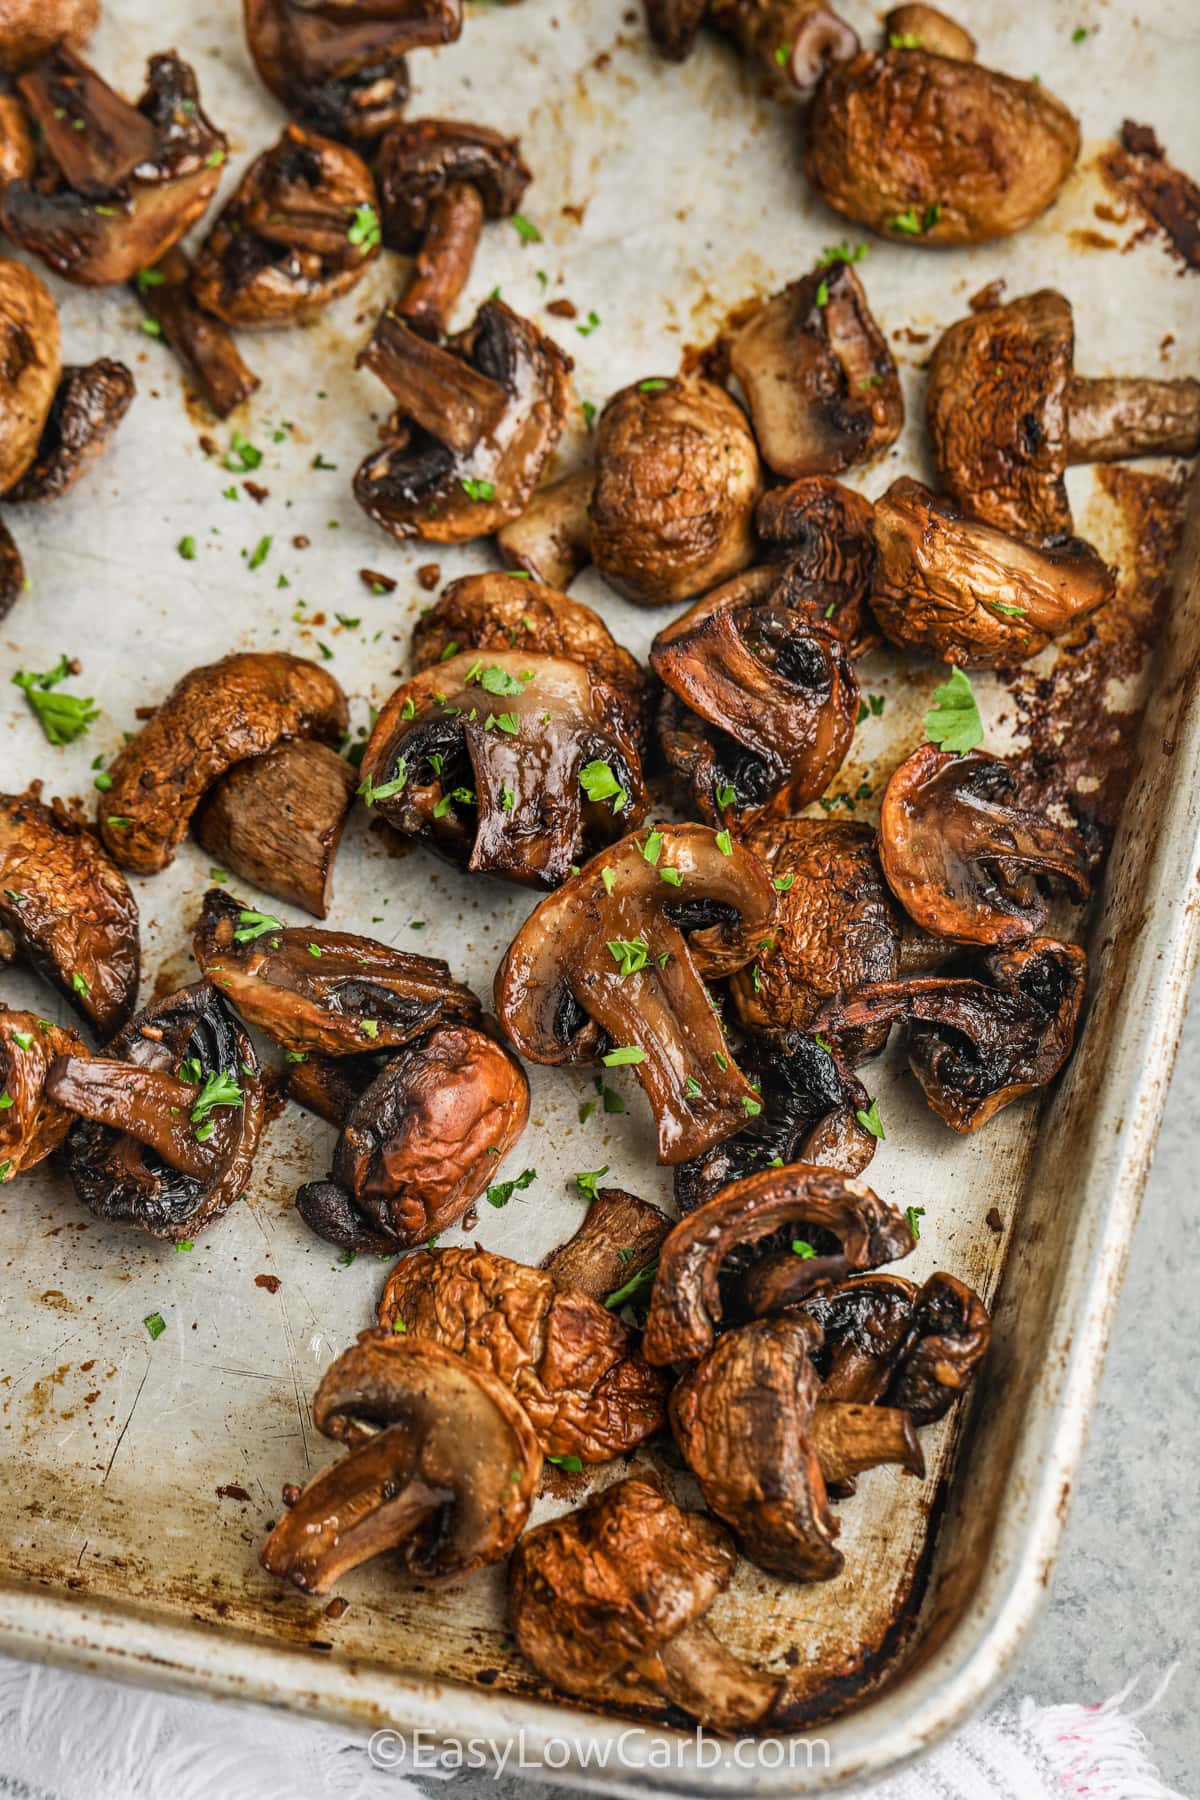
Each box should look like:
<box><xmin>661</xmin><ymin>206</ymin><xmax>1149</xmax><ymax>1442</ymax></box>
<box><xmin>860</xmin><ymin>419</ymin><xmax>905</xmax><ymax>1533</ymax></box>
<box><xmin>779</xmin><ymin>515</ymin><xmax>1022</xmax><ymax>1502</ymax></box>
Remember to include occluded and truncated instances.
<box><xmin>0</xmin><ymin>0</ymin><xmax>1200</xmax><ymax>1795</ymax></box>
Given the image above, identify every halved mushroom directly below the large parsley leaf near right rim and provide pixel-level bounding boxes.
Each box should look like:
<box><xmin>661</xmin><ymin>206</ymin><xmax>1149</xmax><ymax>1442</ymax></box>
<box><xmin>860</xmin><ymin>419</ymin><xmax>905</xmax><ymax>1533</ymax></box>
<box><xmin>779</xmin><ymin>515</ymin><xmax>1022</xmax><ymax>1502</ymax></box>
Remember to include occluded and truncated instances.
<box><xmin>874</xmin><ymin>743</ymin><xmax>1088</xmax><ymax>950</ymax></box>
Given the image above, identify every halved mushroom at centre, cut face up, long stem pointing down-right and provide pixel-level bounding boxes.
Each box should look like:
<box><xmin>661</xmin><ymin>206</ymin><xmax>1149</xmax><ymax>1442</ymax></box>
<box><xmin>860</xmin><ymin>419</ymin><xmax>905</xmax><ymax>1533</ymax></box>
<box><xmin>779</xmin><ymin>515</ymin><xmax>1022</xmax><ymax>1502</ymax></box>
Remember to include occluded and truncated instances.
<box><xmin>495</xmin><ymin>824</ymin><xmax>775</xmax><ymax>1163</ymax></box>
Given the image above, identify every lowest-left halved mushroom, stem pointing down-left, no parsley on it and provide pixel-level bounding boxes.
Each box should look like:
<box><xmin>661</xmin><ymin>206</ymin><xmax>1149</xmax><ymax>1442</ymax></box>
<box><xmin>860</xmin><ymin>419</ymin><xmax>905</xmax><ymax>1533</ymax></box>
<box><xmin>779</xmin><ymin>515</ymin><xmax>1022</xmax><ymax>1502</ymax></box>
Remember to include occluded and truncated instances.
<box><xmin>268</xmin><ymin>1330</ymin><xmax>542</xmax><ymax>1595</ymax></box>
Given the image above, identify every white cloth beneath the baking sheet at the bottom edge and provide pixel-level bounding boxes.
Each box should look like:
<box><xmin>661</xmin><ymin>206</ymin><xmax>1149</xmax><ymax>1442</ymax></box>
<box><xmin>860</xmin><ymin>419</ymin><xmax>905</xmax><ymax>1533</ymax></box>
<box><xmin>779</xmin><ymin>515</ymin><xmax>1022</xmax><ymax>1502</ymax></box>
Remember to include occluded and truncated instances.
<box><xmin>0</xmin><ymin>1658</ymin><xmax>1187</xmax><ymax>1800</ymax></box>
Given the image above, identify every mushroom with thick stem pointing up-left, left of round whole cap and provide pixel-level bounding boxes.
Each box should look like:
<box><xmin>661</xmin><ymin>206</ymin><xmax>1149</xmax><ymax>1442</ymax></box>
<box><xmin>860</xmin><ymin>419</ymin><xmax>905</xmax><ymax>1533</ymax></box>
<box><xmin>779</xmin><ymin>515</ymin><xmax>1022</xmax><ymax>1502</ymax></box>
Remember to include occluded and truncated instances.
<box><xmin>354</xmin><ymin>301</ymin><xmax>572</xmax><ymax>544</ymax></box>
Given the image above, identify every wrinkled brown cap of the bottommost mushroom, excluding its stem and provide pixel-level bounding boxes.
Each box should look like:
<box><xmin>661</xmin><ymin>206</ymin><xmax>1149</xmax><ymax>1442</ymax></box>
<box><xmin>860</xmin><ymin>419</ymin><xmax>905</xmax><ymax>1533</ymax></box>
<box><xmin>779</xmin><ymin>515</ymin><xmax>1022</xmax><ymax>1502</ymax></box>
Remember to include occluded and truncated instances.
<box><xmin>509</xmin><ymin>1476</ymin><xmax>738</xmax><ymax>1694</ymax></box>
